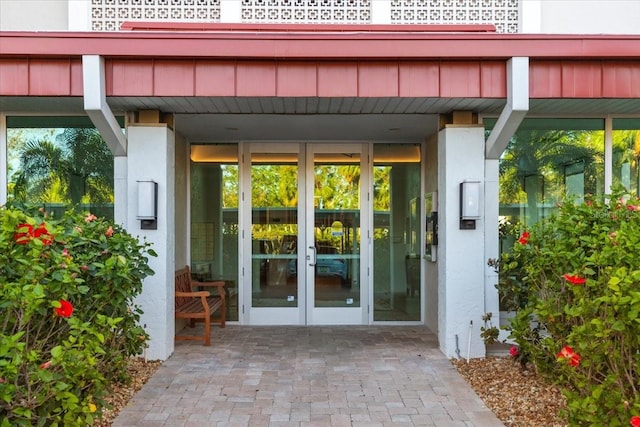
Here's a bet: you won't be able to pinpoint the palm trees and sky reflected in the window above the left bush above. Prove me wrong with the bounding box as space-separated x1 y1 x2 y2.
13 128 113 204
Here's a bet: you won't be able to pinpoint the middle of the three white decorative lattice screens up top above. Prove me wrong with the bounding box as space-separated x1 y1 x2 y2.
242 0 375 24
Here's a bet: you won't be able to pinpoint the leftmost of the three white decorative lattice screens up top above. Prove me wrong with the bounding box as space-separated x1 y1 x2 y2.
91 0 220 31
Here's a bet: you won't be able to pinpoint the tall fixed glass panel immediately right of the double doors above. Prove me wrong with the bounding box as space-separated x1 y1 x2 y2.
373 144 424 321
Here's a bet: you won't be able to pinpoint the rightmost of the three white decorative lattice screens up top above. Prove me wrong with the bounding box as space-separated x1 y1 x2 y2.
391 0 520 33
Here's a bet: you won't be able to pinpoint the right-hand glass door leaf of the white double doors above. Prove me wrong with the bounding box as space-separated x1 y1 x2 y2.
307 144 366 324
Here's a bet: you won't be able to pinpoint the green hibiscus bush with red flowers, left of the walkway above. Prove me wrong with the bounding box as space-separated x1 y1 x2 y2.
0 207 155 427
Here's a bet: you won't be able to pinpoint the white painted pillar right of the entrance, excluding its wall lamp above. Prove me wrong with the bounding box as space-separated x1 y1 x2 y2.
438 125 487 358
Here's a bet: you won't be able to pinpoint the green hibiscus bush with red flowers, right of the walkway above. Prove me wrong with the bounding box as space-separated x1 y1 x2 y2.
499 191 640 426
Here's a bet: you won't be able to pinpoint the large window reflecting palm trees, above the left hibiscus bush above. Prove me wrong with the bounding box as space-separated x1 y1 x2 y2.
7 116 114 220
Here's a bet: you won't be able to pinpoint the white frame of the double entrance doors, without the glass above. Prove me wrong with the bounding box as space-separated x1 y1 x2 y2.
238 141 372 325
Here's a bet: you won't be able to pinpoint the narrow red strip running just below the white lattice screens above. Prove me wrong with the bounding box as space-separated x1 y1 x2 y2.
120 21 496 33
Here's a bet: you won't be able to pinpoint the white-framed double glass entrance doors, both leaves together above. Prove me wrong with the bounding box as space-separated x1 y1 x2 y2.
240 143 369 325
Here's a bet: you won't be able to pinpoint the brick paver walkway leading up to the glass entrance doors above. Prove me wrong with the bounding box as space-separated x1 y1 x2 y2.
113 325 503 427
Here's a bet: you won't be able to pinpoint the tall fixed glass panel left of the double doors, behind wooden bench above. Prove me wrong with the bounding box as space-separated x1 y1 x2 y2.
191 144 239 320
